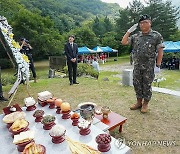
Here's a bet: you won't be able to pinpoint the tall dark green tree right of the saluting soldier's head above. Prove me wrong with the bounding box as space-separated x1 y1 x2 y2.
142 0 179 40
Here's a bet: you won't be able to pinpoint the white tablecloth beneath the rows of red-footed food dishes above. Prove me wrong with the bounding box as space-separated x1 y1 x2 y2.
0 105 130 154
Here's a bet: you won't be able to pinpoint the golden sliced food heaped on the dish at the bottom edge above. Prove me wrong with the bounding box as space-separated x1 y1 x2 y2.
22 142 46 154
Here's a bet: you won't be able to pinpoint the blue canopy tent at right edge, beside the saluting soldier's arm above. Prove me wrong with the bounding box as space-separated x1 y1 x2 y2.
163 41 180 52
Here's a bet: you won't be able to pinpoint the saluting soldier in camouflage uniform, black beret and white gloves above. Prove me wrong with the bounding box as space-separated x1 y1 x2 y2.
121 15 164 113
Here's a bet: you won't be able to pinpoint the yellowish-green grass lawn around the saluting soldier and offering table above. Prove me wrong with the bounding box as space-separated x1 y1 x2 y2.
0 58 180 154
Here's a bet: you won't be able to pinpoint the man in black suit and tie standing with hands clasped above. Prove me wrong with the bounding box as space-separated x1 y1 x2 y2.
64 35 79 85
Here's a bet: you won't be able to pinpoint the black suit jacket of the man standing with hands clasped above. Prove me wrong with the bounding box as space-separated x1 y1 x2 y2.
64 42 78 61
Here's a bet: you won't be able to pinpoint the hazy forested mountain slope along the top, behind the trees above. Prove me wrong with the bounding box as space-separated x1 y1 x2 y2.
20 0 120 32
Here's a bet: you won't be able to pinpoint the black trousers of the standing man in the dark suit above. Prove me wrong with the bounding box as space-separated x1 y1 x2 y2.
67 61 77 83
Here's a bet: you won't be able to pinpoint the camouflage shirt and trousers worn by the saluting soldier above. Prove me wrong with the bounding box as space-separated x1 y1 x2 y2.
128 30 163 102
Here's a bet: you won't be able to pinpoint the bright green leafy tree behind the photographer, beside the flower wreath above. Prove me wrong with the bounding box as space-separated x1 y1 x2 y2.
12 8 64 58
